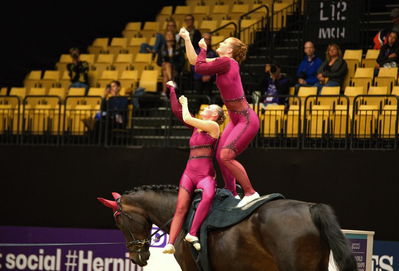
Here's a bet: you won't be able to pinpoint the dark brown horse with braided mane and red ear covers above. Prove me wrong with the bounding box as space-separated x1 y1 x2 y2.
98 185 357 271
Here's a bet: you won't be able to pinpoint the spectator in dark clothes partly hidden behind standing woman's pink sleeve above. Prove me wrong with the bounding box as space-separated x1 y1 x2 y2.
192 33 217 98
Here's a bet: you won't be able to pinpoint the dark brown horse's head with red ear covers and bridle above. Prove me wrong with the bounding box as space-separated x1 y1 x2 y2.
97 193 152 266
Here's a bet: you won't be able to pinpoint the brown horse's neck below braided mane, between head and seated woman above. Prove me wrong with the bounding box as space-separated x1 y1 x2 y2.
129 191 177 232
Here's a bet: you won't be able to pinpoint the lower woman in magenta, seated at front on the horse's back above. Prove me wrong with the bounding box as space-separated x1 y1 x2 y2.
163 81 224 253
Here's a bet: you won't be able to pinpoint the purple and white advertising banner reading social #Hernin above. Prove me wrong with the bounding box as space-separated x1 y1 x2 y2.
0 226 180 271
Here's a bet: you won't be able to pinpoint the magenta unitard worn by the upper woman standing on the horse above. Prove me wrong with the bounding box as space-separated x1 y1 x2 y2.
195 49 259 196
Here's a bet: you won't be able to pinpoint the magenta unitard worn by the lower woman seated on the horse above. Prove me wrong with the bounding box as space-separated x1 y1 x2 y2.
168 86 217 244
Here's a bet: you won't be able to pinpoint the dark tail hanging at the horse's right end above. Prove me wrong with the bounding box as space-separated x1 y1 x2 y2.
310 204 357 271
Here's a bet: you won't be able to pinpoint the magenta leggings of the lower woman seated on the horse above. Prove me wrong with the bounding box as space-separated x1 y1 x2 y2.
169 172 216 244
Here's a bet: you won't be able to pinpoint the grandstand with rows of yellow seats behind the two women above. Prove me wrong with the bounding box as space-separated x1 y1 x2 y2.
0 0 399 149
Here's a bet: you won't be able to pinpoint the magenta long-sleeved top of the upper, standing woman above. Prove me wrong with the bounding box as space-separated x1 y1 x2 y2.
195 49 244 101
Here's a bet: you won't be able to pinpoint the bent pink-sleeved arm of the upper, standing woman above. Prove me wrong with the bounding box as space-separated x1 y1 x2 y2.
195 48 231 75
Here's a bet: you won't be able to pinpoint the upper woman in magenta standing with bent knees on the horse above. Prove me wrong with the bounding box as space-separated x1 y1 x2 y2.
179 28 259 207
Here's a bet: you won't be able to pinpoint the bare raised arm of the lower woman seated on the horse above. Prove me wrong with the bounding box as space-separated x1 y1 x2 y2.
179 96 220 138
